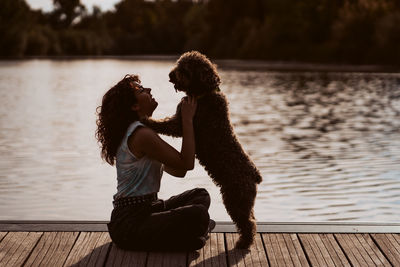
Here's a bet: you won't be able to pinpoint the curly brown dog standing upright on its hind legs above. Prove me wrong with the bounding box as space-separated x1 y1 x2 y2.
144 51 262 249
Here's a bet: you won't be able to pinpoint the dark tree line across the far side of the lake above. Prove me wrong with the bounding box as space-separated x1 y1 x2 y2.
0 0 400 65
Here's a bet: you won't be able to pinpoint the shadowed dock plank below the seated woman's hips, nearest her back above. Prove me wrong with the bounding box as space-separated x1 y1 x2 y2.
105 244 148 267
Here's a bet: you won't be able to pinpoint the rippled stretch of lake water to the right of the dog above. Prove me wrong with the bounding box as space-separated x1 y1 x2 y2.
223 69 400 221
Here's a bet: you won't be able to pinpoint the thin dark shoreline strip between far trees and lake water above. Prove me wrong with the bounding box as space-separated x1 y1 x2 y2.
0 54 400 73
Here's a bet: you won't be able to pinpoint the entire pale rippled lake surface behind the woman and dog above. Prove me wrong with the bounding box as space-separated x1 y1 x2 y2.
0 59 400 222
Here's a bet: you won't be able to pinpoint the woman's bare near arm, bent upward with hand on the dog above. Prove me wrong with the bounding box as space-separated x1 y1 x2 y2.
128 98 197 171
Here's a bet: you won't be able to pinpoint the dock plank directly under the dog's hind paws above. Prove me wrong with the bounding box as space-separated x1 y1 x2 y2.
225 233 269 267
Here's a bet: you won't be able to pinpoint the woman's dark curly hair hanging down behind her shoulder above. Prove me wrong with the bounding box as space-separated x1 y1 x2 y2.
96 74 140 165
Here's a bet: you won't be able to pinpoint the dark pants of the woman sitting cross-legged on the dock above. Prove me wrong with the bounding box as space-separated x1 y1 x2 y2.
108 188 210 251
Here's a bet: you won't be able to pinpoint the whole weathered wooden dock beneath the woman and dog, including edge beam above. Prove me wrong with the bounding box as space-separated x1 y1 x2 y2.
0 221 400 267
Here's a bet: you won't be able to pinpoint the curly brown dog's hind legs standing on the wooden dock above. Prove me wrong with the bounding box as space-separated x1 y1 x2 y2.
221 183 257 249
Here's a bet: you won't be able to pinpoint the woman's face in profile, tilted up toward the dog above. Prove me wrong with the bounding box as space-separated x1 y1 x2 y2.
132 83 158 117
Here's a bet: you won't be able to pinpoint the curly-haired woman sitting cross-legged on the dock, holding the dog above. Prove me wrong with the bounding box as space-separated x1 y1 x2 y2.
96 75 215 250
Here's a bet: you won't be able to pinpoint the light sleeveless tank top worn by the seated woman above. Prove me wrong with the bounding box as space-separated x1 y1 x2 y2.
114 121 163 200
